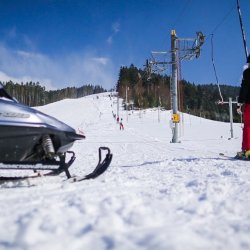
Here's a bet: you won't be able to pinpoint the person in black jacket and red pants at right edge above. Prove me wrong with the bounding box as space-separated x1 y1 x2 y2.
236 55 250 159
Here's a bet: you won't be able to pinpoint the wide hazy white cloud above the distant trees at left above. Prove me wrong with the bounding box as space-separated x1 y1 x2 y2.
0 44 116 89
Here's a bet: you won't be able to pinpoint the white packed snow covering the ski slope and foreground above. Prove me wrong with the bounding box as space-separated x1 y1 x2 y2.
0 93 250 250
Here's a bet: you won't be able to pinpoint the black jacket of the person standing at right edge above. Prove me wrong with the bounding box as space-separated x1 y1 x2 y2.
238 67 250 103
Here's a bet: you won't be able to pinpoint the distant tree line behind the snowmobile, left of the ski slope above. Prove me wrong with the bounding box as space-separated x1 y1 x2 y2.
1 81 106 107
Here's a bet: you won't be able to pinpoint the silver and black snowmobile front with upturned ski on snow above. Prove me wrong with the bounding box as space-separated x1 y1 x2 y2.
0 83 112 181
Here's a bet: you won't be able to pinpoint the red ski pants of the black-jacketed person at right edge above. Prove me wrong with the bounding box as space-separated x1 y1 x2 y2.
242 104 250 150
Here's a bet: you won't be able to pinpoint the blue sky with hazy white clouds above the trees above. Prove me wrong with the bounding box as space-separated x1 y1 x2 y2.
0 0 250 89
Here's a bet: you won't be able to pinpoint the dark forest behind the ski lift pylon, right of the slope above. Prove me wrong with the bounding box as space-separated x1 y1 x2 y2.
116 64 240 122
